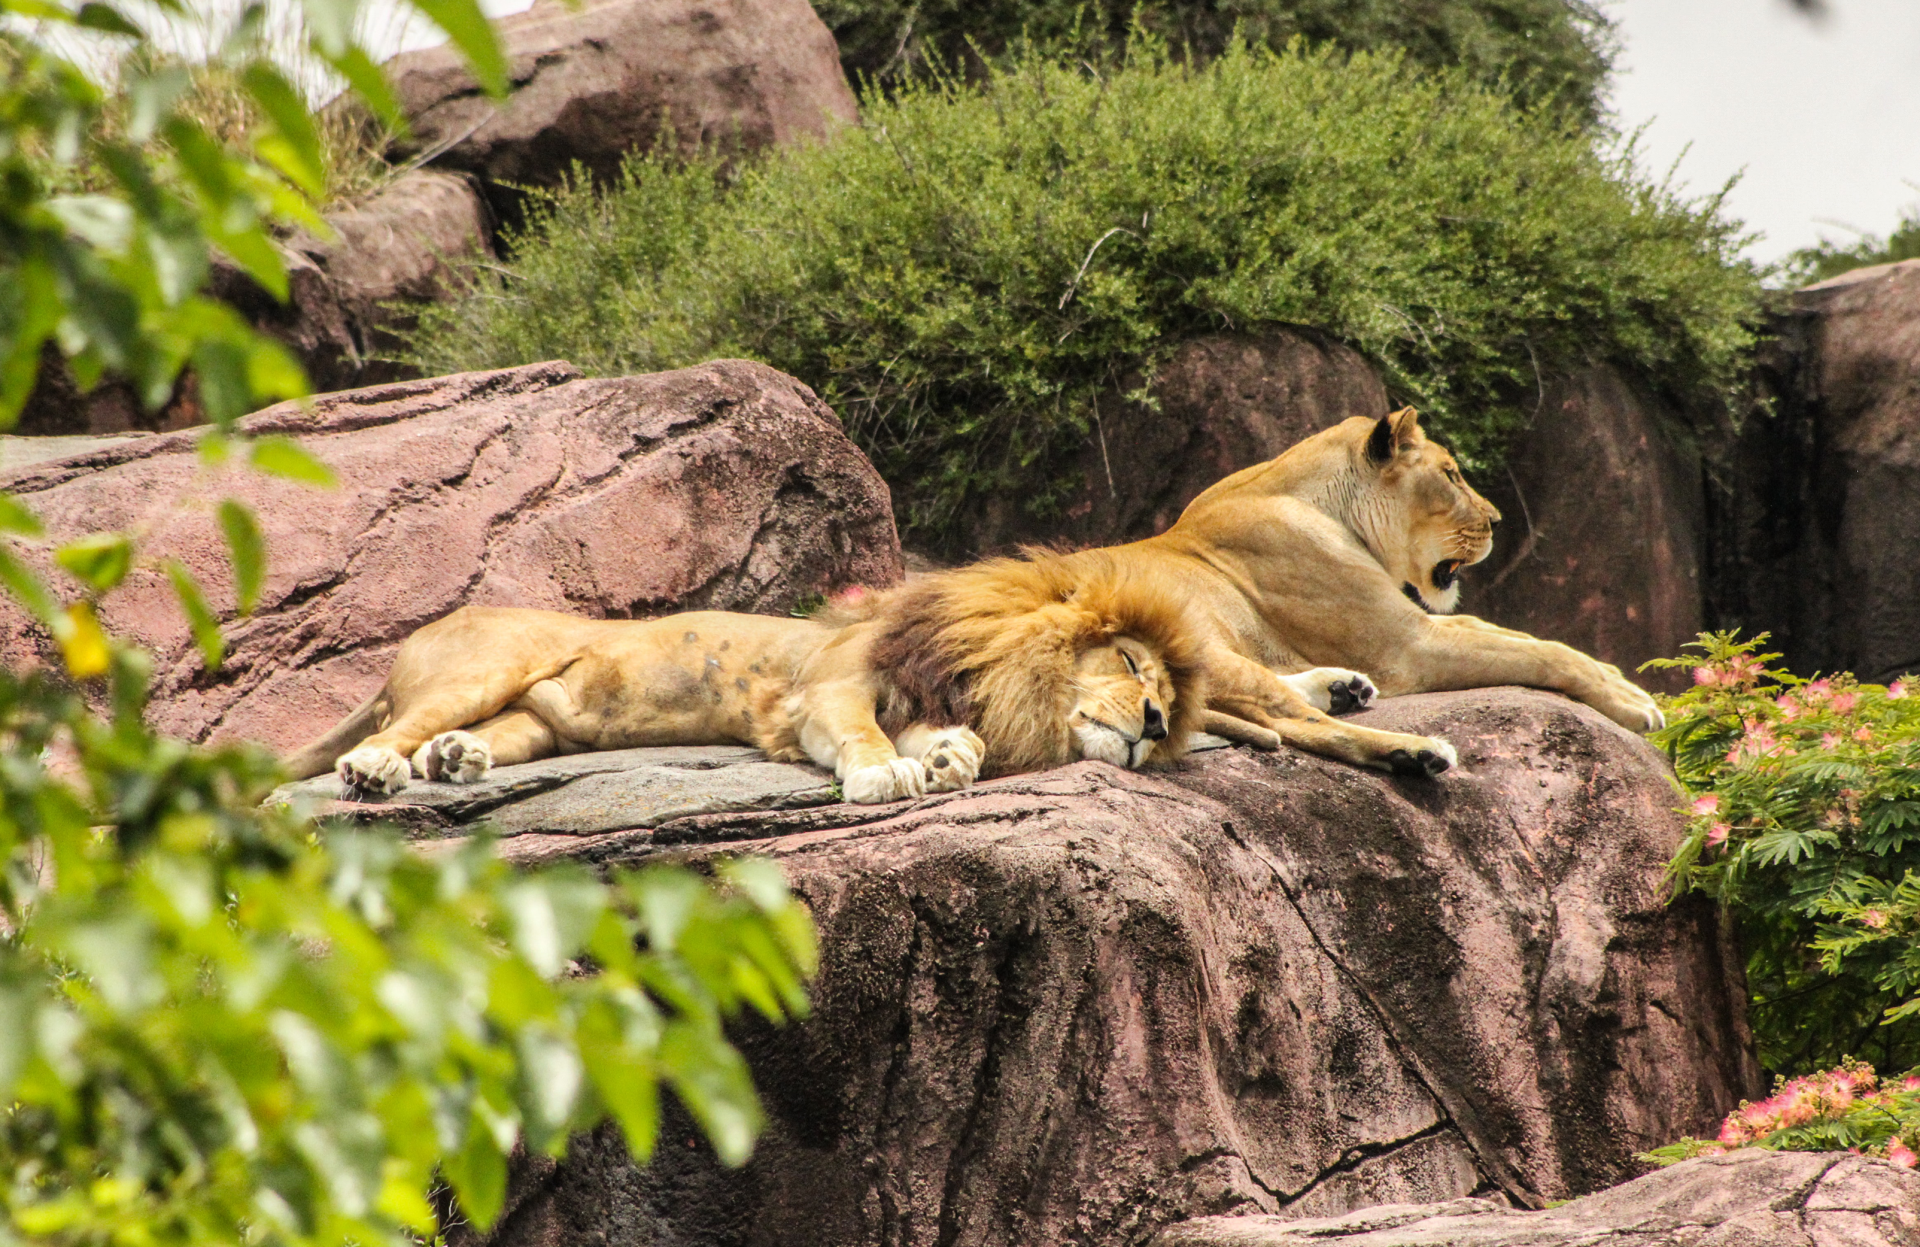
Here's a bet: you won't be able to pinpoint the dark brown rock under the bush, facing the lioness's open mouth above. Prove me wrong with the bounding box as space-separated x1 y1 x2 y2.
1461 367 1707 692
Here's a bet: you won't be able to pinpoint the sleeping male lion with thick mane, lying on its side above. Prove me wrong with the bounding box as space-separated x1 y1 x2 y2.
288 553 1373 803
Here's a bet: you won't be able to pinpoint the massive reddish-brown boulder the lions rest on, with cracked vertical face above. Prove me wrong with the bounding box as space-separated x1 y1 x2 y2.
445 690 1757 1247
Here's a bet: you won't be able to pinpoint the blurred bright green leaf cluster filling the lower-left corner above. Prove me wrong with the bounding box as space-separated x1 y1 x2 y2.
0 649 814 1247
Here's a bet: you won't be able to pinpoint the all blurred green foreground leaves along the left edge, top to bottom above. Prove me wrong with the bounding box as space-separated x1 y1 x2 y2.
0 9 814 1247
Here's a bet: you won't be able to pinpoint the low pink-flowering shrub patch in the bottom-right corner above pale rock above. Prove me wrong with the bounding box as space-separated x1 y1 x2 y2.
1640 1061 1920 1168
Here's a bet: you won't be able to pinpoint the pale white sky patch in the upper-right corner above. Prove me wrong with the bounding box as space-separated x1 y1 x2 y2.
1605 0 1920 261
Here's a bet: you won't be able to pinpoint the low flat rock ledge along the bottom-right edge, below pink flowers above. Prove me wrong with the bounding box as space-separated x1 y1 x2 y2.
1152 1147 1920 1247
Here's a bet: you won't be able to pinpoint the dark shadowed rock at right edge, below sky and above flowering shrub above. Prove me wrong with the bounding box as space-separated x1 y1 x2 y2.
1711 259 1920 680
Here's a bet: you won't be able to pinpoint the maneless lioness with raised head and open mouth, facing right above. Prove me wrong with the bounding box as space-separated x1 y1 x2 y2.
1044 407 1665 774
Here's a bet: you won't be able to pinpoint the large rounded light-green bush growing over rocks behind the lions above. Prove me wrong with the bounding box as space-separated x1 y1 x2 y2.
413 48 1757 542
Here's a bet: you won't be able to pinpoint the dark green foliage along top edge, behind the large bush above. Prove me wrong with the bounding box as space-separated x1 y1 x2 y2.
814 0 1613 119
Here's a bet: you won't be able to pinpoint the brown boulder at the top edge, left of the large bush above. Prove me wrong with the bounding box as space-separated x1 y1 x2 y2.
386 0 858 184
